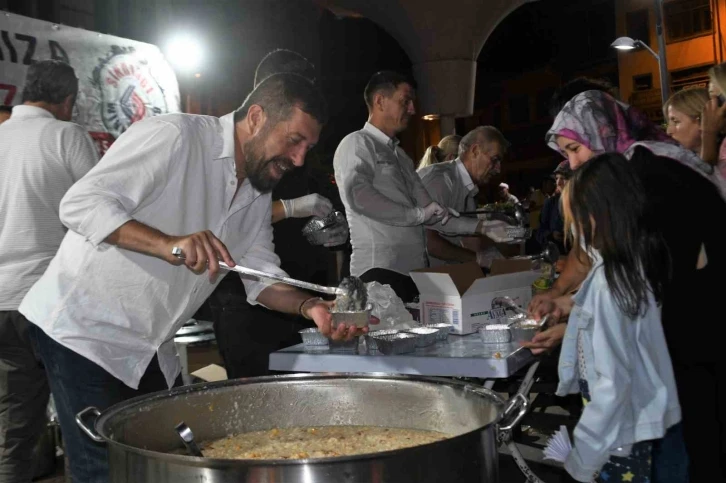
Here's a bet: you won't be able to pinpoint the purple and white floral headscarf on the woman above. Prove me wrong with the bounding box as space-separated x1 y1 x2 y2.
545 91 726 199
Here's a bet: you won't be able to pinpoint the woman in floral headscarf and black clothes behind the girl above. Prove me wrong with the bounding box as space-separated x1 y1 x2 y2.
530 91 726 481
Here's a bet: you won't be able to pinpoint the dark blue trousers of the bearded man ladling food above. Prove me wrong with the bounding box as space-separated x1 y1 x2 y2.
30 324 181 483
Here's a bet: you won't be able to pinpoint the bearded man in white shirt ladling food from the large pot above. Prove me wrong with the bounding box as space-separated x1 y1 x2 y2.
20 74 354 483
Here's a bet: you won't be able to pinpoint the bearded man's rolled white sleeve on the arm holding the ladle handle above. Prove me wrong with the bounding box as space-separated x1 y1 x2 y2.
60 119 185 246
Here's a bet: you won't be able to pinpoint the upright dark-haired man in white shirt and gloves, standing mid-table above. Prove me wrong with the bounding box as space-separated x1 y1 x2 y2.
333 71 520 301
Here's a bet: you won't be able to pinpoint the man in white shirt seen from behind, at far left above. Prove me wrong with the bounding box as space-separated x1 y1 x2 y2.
0 60 98 483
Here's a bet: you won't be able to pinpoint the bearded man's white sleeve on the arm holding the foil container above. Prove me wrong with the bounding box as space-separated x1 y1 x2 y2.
235 197 288 305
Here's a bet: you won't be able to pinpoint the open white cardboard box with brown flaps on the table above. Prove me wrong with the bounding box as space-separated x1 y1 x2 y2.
411 260 542 334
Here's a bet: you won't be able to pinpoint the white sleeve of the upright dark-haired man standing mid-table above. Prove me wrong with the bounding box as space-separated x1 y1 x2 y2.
333 136 425 226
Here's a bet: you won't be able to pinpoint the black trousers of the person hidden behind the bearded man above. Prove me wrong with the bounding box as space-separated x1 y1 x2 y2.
209 277 315 379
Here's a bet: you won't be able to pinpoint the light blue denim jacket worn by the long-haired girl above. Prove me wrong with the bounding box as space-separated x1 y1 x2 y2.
557 251 681 481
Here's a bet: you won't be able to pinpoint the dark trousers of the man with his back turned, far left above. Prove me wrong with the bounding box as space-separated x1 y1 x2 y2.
0 310 49 483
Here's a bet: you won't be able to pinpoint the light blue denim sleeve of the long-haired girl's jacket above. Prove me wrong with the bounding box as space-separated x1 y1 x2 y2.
565 287 635 481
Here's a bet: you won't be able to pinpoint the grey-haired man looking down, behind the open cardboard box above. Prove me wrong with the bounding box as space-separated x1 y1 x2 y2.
418 126 509 268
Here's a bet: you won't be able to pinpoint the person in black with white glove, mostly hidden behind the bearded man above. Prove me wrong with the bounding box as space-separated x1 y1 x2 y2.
209 49 348 379
